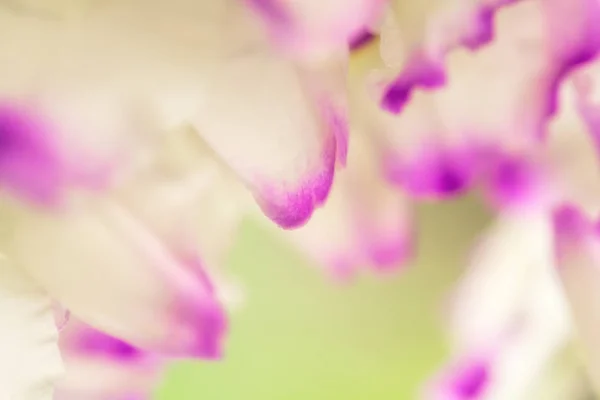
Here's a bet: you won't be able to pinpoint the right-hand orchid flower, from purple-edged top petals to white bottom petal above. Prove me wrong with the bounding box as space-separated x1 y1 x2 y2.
352 0 600 400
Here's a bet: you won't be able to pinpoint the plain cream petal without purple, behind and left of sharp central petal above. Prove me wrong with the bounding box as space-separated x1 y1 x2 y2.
117 127 247 268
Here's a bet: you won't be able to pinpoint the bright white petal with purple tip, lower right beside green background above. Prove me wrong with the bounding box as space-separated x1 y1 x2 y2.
424 214 573 400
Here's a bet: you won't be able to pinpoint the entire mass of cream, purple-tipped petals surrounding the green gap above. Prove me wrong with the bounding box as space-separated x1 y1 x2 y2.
5 0 600 400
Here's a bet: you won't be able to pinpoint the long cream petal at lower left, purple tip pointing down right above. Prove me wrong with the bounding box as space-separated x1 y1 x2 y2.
4 195 227 358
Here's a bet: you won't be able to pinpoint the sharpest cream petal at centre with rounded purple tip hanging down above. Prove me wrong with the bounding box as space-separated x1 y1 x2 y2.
195 54 337 228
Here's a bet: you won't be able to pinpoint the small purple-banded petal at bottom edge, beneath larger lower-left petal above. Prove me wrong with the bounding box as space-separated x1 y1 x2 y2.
56 321 163 400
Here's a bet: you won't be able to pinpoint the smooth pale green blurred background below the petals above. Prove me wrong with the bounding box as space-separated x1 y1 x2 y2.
157 198 487 400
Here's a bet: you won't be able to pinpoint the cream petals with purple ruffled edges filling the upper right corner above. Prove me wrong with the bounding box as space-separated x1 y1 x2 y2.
373 0 600 208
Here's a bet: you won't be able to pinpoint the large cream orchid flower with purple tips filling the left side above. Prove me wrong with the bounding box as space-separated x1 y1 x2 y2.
0 0 386 400
